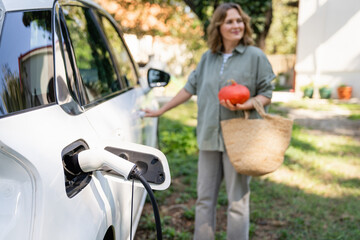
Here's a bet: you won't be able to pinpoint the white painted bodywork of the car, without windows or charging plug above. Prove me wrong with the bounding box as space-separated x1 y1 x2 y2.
0 0 170 240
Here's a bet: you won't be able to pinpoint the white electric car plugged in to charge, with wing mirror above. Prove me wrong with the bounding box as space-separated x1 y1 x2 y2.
0 0 170 240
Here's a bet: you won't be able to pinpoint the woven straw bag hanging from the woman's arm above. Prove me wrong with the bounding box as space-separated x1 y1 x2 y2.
221 98 293 176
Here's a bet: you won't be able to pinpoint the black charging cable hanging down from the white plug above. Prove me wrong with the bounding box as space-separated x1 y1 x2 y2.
129 168 162 240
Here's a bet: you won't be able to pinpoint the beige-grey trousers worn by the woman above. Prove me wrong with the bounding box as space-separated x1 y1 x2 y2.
194 151 251 240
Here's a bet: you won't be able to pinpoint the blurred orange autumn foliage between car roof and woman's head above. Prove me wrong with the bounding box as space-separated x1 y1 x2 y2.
96 0 206 72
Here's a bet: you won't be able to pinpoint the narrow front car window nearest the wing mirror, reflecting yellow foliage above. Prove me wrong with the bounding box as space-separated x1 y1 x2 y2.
99 14 137 88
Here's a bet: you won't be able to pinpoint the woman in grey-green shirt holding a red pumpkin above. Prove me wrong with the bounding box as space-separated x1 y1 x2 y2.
145 3 275 240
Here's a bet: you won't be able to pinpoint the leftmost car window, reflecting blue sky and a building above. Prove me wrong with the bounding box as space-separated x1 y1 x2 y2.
0 10 55 117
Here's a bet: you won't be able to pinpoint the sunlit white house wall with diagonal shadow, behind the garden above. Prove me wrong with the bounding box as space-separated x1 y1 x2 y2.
295 0 360 98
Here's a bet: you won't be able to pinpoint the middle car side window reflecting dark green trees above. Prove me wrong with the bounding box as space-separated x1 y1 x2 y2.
63 6 121 103
